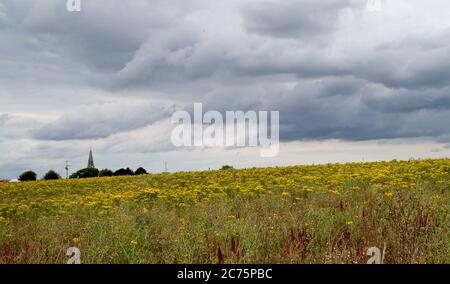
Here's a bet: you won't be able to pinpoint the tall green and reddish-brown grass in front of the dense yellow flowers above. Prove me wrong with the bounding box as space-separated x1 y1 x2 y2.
0 183 450 264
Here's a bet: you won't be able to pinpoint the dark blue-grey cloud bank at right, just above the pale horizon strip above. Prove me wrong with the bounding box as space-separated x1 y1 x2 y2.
270 79 450 140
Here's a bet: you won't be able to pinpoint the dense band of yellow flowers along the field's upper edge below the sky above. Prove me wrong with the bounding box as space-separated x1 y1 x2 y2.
0 159 450 217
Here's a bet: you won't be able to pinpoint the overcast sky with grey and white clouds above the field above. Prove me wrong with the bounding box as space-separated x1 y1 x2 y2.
0 0 450 179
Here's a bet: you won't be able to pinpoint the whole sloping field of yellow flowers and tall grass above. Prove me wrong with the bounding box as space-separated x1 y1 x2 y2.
0 159 450 263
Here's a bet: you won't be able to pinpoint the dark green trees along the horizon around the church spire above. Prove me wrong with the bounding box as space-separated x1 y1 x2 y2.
19 167 148 181
